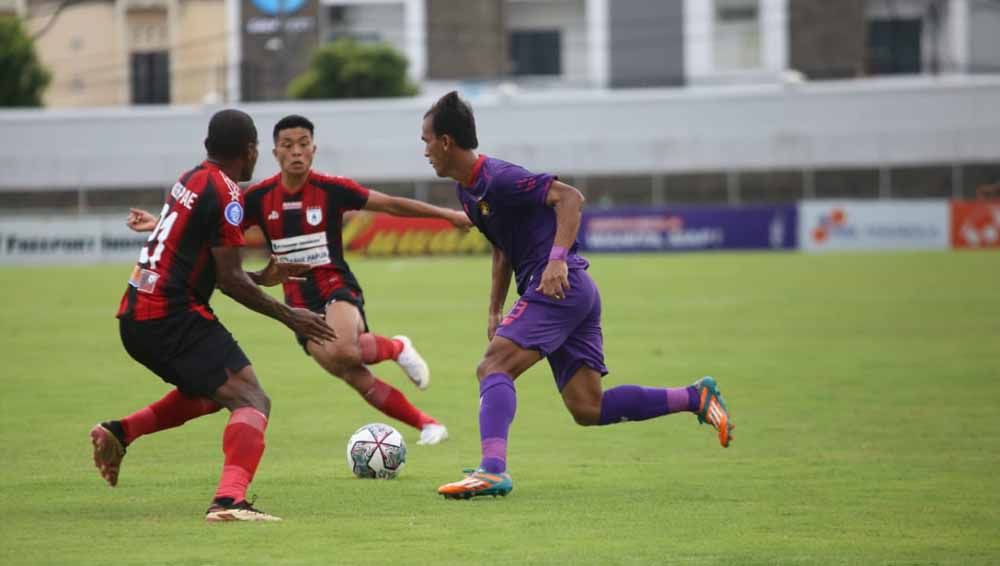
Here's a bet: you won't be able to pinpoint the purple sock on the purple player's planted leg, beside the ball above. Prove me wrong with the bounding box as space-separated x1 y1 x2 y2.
479 373 517 474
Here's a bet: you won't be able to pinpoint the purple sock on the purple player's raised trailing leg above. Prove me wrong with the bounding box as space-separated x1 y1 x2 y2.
598 385 698 425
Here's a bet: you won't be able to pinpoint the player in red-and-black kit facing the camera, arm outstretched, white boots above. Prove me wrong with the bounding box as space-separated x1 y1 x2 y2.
243 115 471 444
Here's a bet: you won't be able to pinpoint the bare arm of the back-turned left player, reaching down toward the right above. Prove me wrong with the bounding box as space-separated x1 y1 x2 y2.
212 246 337 344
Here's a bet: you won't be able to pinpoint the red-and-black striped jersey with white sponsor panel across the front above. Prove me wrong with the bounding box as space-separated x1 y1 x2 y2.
243 171 369 311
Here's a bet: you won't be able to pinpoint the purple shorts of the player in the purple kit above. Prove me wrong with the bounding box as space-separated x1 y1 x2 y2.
497 269 608 391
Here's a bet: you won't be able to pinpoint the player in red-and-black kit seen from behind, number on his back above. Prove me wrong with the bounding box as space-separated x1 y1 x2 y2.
90 110 336 521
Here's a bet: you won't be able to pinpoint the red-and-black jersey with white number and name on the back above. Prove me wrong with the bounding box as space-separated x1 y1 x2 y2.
118 161 244 320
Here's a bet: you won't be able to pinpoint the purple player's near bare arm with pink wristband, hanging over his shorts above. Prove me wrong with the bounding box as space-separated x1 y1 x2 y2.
536 181 584 299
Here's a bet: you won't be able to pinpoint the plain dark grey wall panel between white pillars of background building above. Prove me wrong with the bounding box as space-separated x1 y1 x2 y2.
609 0 684 87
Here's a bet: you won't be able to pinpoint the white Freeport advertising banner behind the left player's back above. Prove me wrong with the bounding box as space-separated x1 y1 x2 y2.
0 214 149 265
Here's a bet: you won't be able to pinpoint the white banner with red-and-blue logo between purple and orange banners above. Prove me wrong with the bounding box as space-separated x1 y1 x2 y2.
799 200 950 252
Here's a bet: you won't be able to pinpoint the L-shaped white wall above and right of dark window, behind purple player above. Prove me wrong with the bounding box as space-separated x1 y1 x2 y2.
507 0 589 83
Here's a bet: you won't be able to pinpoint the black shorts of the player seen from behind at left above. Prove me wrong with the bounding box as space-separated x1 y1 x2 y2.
118 312 250 397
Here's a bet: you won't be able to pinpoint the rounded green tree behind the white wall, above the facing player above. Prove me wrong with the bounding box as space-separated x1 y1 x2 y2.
288 38 417 99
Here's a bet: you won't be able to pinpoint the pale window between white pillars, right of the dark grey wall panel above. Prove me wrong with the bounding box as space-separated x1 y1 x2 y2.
713 0 762 71
